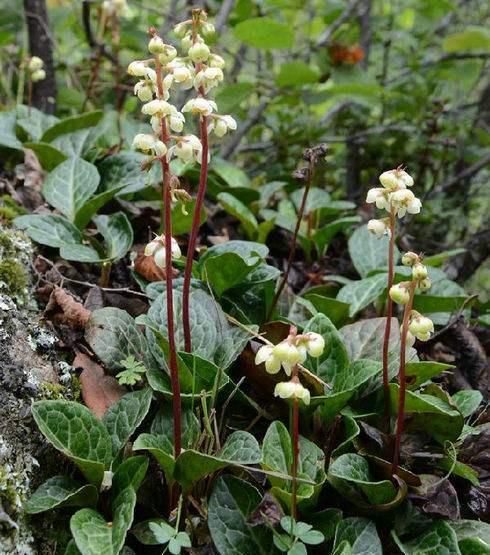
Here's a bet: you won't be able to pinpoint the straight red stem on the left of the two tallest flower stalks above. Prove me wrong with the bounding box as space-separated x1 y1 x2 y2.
150 33 182 458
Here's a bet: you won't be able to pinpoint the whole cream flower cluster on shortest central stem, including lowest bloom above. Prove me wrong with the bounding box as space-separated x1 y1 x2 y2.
255 328 325 404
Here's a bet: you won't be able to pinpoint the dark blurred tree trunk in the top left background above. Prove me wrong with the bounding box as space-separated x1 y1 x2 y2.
24 0 56 114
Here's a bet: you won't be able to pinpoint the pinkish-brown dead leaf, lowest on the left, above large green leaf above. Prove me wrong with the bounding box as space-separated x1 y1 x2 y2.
73 353 126 419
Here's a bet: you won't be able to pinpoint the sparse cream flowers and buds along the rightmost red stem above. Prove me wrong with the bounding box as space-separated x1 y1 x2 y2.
389 252 434 345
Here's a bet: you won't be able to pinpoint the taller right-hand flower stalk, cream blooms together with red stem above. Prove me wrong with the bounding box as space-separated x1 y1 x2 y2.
366 166 422 418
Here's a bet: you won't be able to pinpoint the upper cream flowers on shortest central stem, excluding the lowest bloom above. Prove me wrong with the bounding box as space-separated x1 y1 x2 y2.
255 332 325 376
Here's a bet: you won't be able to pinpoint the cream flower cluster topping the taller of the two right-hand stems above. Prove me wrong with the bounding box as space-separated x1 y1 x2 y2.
366 167 422 233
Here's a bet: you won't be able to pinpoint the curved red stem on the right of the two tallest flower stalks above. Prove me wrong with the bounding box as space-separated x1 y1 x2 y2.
182 9 209 353
